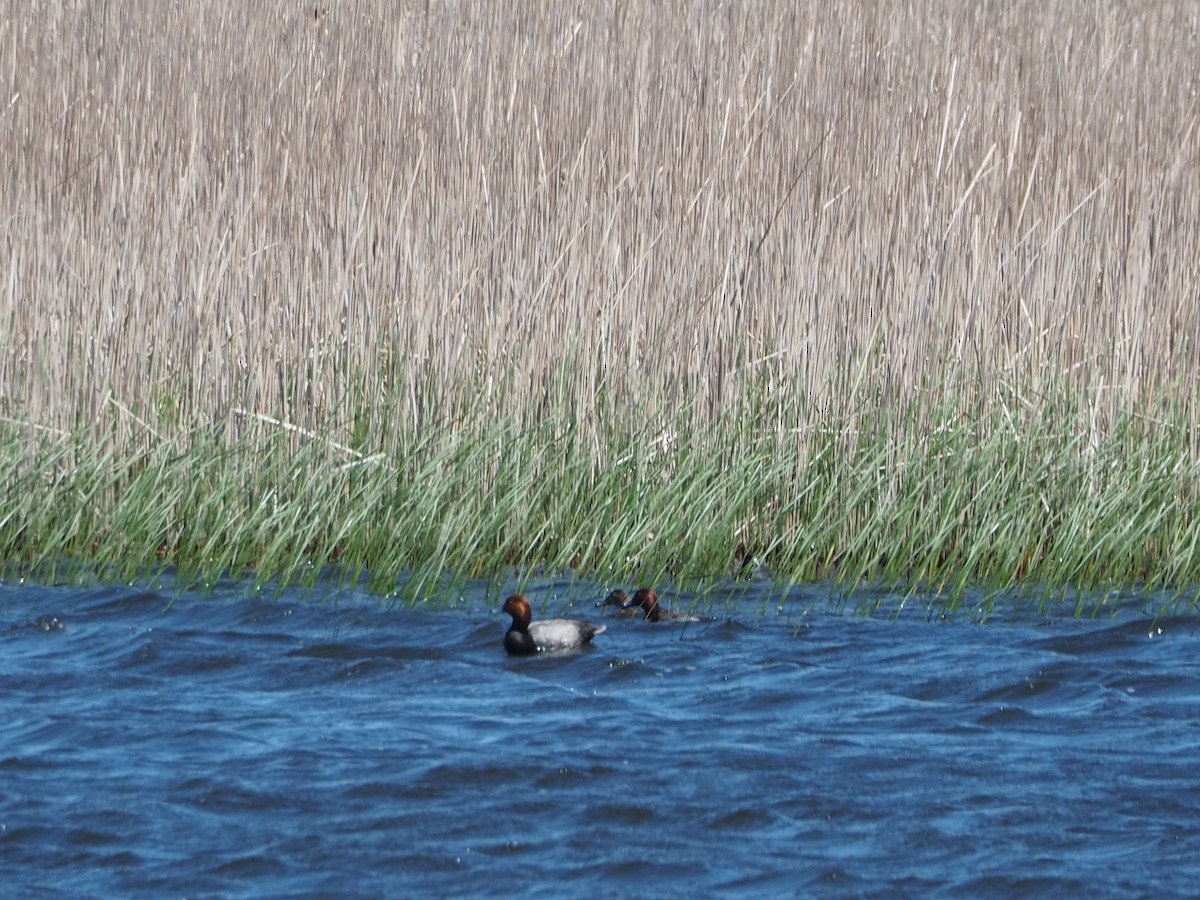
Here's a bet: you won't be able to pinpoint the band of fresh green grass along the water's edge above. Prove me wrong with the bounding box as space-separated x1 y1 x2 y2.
0 367 1200 612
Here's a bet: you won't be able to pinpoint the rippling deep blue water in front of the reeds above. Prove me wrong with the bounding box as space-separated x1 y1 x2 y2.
0 573 1200 898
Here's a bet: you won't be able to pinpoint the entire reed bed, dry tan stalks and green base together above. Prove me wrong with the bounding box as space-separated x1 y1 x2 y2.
0 0 1200 606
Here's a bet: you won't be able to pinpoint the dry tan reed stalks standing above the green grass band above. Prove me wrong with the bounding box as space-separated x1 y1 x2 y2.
0 0 1200 445
